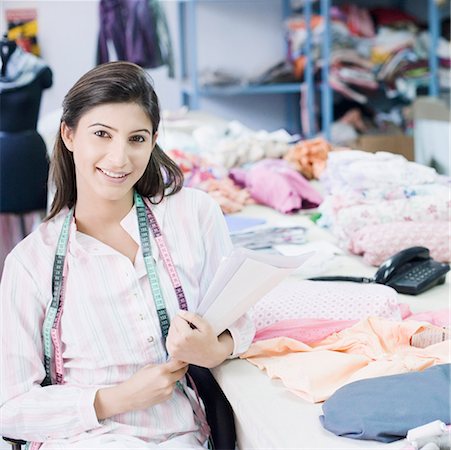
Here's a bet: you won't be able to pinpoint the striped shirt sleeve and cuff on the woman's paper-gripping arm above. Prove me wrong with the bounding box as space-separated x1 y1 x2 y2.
201 195 255 358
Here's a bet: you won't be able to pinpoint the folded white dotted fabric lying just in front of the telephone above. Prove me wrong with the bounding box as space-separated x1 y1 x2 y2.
250 280 401 331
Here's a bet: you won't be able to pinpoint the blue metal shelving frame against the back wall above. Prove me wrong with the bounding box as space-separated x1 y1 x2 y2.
178 0 439 138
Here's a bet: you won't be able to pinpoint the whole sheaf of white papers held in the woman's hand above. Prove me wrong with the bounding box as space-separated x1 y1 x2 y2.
196 248 313 336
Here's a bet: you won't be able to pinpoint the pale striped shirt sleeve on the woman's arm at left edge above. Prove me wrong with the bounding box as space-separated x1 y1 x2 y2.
0 254 100 442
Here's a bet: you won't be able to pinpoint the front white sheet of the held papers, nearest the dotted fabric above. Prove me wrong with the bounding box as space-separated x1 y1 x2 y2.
197 251 310 335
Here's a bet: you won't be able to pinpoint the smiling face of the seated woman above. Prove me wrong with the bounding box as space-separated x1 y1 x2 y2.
61 103 156 201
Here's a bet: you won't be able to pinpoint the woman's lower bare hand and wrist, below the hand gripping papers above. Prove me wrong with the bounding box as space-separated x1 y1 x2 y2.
94 359 188 420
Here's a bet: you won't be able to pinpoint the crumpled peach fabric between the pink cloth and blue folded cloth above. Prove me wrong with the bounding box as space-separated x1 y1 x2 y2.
241 317 450 403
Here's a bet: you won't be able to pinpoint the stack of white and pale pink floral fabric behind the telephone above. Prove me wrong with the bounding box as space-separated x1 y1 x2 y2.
317 150 451 265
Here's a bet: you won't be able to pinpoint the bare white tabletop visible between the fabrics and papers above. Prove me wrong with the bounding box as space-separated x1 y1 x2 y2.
213 205 450 450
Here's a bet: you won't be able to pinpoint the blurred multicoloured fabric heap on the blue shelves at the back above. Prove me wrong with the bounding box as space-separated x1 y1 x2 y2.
286 5 451 104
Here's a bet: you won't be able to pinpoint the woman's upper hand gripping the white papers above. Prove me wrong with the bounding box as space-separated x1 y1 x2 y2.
166 310 237 368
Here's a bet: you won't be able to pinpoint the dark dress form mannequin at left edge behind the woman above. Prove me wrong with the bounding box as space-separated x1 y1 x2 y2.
0 36 52 273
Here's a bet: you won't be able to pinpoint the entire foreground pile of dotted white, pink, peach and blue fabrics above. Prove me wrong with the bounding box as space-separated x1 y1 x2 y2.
247 280 451 442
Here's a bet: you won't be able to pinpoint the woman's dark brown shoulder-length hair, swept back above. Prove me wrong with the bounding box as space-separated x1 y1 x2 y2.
46 61 183 220
